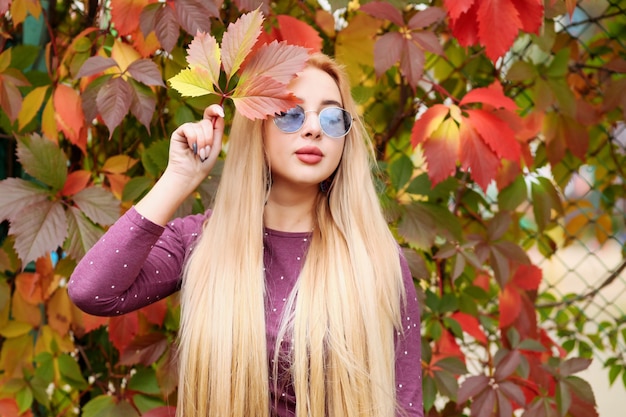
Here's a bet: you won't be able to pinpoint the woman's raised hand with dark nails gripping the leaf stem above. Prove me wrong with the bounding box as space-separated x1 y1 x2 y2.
166 104 224 186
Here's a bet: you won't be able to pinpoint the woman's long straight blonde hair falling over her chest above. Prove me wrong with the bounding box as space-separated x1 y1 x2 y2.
178 54 405 417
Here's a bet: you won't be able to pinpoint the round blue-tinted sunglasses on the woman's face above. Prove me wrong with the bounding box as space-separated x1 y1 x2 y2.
274 106 352 139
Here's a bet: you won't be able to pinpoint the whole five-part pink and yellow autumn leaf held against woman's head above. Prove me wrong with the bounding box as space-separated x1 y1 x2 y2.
169 9 308 119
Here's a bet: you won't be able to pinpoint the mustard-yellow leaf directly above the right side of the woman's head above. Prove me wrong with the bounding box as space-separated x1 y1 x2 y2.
335 14 382 85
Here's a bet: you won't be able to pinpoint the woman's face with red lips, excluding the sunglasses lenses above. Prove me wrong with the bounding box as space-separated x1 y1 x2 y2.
264 67 345 191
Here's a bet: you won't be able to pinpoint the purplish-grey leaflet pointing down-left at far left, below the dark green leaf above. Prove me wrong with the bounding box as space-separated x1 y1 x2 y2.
9 201 67 265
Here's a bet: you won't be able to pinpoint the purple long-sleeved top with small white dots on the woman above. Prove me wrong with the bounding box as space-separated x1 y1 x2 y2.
68 208 423 417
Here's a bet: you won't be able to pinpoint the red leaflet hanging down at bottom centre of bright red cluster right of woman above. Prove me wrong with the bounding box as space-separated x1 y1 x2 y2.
460 123 500 190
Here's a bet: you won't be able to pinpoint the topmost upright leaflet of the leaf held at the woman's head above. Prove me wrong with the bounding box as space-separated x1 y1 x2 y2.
222 9 263 80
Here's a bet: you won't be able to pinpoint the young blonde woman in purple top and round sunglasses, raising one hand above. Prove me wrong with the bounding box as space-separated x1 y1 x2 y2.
69 54 423 417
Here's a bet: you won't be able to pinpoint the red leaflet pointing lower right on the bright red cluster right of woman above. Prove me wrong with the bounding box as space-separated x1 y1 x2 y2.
463 109 522 161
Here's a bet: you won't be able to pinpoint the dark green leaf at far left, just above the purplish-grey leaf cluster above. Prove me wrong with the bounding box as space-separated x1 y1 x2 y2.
17 135 67 191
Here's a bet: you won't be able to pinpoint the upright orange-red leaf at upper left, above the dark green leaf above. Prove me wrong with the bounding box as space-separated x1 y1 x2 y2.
53 84 87 152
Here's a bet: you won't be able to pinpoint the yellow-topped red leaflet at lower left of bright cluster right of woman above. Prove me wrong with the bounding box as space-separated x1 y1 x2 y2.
422 119 460 186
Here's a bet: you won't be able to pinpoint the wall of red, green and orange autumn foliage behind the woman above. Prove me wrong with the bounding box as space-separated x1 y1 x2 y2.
0 0 626 417
